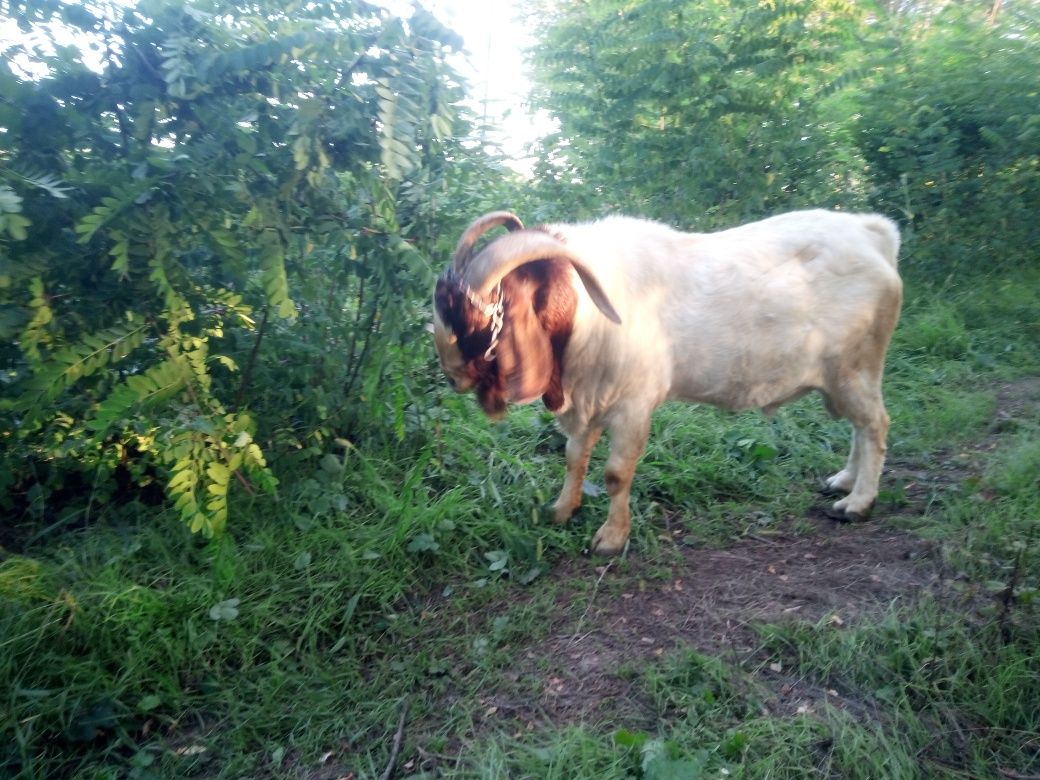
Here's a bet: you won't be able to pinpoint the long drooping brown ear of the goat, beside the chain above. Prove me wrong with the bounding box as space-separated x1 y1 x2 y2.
497 296 553 404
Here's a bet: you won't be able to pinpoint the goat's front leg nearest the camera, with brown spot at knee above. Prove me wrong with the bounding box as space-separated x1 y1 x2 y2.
589 410 650 555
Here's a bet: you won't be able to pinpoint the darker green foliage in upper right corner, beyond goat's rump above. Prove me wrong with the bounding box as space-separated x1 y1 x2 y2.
853 3 1040 274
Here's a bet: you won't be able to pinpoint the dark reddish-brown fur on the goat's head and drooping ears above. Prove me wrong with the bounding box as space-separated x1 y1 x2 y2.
434 260 577 417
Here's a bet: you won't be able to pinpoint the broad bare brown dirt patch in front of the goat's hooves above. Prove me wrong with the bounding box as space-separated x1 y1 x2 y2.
480 517 938 726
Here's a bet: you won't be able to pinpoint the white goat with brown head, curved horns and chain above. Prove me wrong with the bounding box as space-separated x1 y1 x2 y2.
434 210 903 555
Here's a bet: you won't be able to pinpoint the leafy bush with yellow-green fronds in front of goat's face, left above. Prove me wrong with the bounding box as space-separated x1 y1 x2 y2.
0 0 495 534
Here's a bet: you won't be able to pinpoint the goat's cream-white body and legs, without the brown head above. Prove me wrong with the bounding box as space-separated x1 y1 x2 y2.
435 210 902 553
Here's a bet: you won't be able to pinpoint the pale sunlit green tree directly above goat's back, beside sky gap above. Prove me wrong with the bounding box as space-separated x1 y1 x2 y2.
531 0 870 227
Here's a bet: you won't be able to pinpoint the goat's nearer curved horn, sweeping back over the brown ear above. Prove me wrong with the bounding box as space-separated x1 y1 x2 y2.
465 230 621 324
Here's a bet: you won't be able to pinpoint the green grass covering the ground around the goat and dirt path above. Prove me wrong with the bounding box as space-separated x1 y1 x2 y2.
0 271 1040 779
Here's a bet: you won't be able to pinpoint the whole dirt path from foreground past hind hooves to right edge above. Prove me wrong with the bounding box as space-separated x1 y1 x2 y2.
436 379 1040 744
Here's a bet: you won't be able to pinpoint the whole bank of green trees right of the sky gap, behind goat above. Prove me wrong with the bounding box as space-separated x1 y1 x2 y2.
530 0 1040 250
